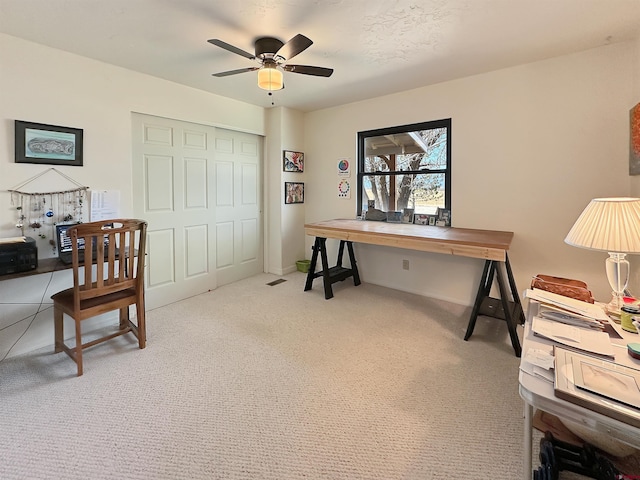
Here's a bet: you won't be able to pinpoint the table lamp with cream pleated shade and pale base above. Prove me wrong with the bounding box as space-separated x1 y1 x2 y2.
564 198 640 313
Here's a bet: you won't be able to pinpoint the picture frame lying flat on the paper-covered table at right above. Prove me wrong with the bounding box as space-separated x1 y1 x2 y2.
554 346 640 428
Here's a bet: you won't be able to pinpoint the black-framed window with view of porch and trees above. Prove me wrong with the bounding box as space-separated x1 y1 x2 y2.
357 118 451 219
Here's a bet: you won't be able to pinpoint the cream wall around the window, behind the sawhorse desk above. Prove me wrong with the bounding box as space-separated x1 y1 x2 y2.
305 42 640 304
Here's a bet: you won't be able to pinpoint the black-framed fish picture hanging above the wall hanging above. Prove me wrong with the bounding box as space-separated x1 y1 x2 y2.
14 120 83 167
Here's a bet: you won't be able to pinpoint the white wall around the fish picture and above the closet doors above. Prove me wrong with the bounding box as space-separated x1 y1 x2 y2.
0 34 265 253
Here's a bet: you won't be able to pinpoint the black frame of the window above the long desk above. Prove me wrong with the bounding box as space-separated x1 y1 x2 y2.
356 118 452 217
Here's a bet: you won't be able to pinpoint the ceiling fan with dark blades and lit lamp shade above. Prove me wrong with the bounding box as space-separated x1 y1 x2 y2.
208 34 333 91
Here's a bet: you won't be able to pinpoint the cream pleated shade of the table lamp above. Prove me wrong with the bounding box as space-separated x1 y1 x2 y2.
564 198 640 253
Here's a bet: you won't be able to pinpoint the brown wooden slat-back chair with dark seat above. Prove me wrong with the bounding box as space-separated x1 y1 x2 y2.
51 219 147 376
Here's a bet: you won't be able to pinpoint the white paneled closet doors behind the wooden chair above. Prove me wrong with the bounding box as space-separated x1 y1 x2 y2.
133 114 263 308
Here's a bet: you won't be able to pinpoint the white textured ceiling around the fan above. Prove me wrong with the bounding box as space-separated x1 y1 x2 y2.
0 0 640 111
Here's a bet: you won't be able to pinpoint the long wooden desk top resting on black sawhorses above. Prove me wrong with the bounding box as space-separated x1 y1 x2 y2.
304 219 513 262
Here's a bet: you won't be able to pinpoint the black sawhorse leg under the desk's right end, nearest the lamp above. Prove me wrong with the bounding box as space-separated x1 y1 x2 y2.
464 254 524 357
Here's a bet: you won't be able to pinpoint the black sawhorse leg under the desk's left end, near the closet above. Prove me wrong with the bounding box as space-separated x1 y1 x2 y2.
304 237 360 300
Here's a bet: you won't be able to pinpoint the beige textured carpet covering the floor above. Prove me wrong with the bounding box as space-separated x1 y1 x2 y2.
0 272 524 480
